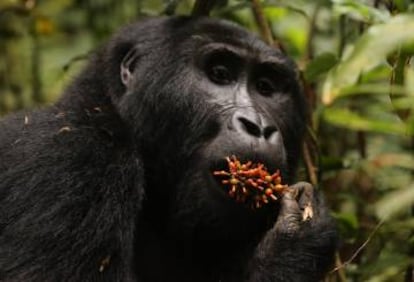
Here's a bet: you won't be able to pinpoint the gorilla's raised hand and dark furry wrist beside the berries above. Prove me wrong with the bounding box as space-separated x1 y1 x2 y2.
247 182 336 282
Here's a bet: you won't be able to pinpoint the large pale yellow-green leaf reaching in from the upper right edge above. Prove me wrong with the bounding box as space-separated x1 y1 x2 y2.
322 15 414 104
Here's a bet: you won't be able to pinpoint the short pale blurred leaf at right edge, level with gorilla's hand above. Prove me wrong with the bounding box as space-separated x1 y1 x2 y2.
375 183 414 219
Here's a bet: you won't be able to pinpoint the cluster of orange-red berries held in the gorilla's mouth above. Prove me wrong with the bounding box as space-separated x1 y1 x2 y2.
213 156 288 209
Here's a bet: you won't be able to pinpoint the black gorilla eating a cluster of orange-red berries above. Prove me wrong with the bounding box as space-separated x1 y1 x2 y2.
0 16 337 282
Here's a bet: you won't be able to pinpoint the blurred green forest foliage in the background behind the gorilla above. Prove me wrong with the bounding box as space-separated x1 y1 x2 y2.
0 0 414 282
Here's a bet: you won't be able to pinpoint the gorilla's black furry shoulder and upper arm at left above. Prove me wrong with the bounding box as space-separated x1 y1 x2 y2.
0 108 142 282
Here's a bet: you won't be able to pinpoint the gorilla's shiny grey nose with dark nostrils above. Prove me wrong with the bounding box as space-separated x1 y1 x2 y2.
232 113 278 144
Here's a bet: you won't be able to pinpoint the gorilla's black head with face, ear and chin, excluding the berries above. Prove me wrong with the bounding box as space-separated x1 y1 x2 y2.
115 18 305 246
